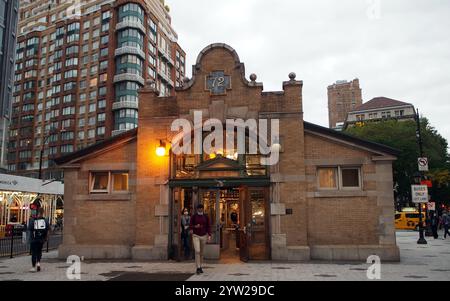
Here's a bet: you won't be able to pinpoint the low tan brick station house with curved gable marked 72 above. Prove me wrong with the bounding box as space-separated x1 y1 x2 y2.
57 44 400 261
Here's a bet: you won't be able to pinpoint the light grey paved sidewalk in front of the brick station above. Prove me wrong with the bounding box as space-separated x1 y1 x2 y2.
0 231 450 281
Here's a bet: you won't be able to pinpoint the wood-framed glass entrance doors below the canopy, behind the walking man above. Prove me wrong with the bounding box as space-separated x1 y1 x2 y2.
170 187 270 261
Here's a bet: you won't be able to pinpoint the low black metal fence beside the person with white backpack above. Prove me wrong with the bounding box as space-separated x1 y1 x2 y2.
0 231 63 258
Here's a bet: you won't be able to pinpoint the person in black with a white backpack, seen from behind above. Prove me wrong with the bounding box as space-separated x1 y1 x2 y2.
28 208 49 272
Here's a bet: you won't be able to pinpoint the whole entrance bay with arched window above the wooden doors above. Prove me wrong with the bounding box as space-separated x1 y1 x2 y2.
169 127 270 261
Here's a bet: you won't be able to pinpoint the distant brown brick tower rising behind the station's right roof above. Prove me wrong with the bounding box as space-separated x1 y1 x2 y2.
328 78 362 129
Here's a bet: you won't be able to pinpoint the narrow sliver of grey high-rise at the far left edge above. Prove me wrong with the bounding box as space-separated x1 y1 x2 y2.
0 0 19 169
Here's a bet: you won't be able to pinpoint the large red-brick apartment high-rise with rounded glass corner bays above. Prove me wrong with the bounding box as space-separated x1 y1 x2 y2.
8 0 185 178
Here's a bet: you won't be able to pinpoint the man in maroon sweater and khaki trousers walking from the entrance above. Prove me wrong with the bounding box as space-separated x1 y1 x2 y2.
190 204 211 275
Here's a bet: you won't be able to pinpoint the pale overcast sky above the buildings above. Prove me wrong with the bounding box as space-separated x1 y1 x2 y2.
170 0 450 141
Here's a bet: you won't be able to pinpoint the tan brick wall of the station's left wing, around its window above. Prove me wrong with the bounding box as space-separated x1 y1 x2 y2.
64 141 136 246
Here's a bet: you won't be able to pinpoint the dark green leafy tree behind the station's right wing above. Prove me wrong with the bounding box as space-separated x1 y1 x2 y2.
345 118 450 209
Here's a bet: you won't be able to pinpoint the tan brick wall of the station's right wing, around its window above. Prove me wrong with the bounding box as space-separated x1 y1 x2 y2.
305 134 386 245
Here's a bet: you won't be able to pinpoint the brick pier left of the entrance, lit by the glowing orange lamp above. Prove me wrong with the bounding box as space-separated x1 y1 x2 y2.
132 118 171 260
